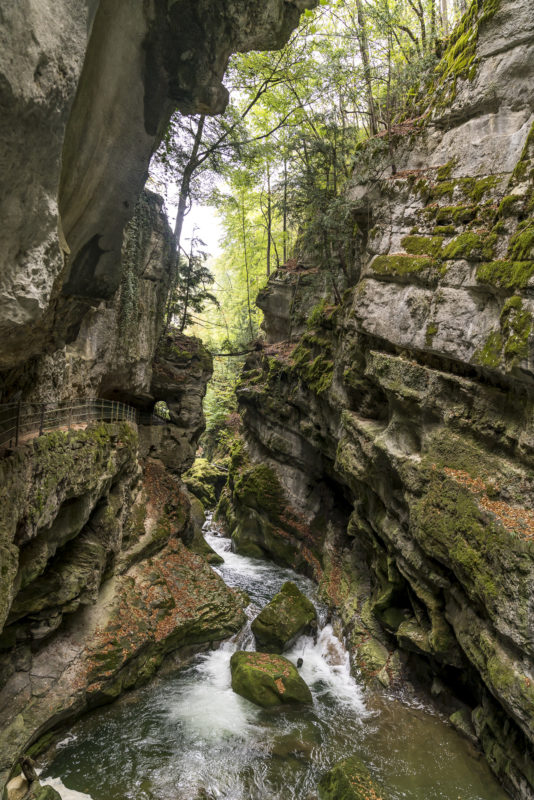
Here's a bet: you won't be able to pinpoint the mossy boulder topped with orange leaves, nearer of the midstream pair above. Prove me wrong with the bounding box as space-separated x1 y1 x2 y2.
230 650 312 708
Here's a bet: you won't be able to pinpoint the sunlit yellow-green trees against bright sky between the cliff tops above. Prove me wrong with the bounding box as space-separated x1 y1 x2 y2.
153 0 465 450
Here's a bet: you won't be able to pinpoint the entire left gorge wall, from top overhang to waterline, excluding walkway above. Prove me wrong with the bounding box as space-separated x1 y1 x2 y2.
0 0 316 792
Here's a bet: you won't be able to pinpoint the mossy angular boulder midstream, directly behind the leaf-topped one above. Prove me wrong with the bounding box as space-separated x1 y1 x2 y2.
251 581 317 653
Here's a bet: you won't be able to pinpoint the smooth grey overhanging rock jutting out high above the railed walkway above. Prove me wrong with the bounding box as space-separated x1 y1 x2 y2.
0 0 316 369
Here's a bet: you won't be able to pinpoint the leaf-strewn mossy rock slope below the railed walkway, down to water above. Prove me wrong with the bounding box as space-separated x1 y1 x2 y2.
0 423 244 786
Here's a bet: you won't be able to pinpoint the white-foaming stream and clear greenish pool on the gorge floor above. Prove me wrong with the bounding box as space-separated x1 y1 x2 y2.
42 515 507 800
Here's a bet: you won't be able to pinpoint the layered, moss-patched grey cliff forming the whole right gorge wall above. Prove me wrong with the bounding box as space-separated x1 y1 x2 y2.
224 0 534 799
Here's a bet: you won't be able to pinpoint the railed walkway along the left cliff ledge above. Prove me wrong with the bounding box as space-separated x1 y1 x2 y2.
0 399 167 455
